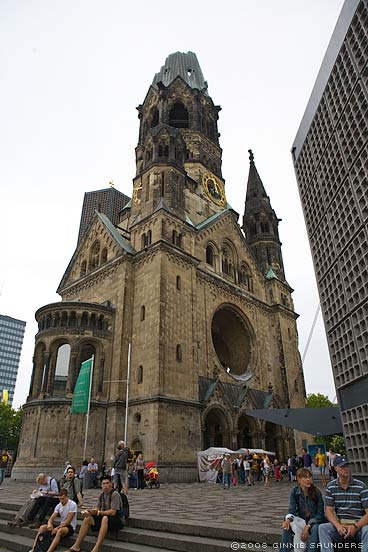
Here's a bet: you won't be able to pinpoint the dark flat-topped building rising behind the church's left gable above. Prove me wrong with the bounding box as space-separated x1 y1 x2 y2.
78 186 130 243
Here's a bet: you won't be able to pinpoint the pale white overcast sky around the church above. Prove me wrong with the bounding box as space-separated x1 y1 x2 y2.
0 0 343 407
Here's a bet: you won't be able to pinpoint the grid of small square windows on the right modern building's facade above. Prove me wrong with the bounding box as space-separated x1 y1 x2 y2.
295 2 368 474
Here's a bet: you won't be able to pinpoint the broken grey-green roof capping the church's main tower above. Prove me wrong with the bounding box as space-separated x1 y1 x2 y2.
152 52 207 95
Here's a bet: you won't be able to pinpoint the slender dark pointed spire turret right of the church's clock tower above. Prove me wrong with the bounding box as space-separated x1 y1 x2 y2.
242 150 285 281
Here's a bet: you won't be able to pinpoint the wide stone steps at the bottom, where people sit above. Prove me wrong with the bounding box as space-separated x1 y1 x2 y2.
0 497 279 552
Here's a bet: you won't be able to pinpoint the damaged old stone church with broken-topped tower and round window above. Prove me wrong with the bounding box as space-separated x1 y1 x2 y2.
14 52 305 481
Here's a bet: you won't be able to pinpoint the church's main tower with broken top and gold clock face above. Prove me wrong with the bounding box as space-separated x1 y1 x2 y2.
131 52 226 231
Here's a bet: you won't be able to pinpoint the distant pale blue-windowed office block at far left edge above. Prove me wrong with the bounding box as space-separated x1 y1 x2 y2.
0 314 26 405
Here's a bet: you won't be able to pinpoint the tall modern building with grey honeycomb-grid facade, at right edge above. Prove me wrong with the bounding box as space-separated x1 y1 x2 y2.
292 0 368 476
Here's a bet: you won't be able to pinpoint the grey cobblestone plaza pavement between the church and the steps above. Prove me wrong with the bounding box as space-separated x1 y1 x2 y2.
0 479 324 534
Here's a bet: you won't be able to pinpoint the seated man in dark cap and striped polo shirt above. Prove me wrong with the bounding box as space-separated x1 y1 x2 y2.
319 456 368 552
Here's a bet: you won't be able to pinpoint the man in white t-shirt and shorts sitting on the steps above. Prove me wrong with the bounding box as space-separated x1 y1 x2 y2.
30 489 77 552
